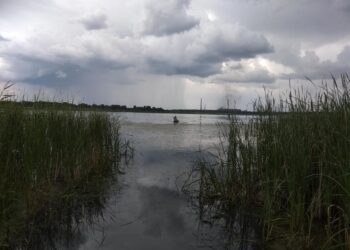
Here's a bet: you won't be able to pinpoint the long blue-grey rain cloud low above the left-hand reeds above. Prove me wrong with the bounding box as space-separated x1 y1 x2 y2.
3 46 130 87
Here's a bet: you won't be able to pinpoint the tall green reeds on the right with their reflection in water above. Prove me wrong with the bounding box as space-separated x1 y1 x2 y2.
183 75 350 249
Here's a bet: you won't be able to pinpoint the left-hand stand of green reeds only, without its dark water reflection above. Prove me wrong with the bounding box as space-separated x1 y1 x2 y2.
0 101 122 249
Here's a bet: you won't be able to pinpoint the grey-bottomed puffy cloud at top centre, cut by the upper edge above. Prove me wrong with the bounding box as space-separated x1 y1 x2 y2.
142 0 199 36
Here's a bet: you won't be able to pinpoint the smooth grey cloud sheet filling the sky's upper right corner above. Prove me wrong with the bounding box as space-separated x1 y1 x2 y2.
221 0 350 44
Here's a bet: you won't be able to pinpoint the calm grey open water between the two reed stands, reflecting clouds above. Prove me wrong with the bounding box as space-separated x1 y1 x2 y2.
74 113 238 250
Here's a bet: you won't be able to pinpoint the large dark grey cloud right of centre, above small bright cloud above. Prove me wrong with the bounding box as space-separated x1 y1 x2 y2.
146 23 273 77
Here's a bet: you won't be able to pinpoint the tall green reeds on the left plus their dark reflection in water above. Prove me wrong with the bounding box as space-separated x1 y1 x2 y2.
0 92 130 249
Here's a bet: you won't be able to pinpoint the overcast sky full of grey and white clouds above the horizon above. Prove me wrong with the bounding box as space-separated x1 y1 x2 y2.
0 0 350 109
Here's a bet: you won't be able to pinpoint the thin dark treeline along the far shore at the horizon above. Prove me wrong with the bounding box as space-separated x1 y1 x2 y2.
0 101 254 115
